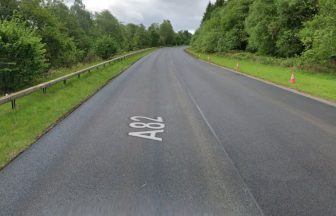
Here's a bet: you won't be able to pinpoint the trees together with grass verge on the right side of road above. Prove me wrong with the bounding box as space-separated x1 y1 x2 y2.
190 0 336 100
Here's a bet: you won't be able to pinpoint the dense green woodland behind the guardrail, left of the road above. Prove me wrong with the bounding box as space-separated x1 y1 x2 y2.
0 0 191 93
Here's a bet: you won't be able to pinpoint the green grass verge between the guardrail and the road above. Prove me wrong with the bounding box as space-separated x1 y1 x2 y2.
0 50 153 168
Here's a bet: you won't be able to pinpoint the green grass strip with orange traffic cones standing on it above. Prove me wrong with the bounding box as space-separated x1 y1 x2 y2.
188 49 336 101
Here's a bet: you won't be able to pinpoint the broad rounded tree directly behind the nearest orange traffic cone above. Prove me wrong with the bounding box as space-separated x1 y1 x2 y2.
246 0 317 57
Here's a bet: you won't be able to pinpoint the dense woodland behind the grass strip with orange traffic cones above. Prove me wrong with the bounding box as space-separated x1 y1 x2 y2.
191 0 336 65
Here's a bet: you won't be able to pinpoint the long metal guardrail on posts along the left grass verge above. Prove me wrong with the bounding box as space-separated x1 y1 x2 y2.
0 48 151 109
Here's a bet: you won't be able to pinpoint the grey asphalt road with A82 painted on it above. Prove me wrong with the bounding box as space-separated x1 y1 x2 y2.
0 48 336 216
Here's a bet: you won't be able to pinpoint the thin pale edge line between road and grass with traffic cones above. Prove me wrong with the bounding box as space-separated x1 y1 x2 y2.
186 51 336 107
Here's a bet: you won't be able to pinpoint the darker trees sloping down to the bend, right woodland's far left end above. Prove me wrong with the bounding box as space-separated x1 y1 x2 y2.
192 0 252 52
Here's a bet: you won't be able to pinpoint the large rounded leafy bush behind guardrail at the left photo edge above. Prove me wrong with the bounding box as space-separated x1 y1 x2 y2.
0 19 47 92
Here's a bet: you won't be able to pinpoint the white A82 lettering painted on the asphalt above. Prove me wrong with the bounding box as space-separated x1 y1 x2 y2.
128 116 165 142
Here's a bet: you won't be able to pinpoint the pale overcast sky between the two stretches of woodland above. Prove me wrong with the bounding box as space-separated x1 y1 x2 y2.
83 0 213 32
